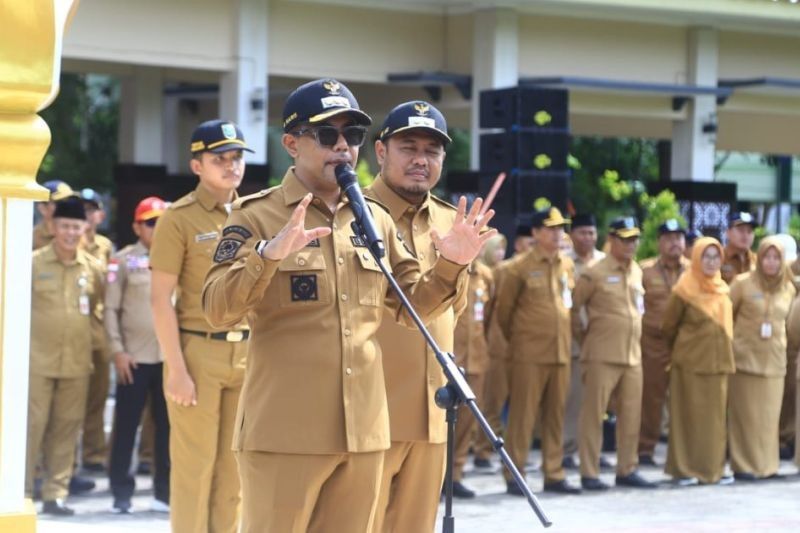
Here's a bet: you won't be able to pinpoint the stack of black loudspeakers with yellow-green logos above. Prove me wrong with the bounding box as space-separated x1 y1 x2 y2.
479 87 570 235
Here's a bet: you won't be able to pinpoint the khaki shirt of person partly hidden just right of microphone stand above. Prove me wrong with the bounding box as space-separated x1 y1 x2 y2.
453 261 494 374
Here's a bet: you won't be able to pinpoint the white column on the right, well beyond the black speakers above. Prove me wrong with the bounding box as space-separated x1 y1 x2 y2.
671 28 718 181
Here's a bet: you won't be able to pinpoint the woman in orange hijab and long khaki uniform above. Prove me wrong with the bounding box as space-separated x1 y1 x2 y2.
662 237 734 485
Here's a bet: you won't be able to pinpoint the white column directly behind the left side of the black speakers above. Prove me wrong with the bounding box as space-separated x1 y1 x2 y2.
470 9 519 169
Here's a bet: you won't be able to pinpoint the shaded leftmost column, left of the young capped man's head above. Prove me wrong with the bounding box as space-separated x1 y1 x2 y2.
119 67 164 165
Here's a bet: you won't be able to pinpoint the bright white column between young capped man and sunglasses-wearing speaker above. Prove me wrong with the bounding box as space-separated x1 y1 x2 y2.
219 0 269 164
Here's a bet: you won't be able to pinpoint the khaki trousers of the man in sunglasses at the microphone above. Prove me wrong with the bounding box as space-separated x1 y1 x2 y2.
238 451 384 533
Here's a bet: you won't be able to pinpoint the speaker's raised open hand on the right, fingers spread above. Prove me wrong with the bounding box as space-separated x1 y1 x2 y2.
431 196 497 265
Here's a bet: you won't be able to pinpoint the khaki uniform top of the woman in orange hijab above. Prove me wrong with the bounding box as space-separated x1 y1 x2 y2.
661 292 735 374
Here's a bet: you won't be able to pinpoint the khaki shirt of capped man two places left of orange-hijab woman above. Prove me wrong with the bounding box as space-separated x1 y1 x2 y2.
572 255 644 366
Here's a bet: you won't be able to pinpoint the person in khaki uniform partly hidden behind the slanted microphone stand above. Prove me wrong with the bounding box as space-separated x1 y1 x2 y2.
453 261 495 498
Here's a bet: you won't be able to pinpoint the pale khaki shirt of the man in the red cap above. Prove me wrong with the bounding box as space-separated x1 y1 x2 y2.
105 241 164 364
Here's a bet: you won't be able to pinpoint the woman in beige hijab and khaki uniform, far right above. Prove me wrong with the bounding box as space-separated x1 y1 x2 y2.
728 237 795 481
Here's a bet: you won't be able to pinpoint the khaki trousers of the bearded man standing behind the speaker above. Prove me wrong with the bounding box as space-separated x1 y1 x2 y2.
372 441 447 533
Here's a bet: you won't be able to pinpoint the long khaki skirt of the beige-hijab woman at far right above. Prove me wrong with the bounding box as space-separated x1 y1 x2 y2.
728 372 784 477
